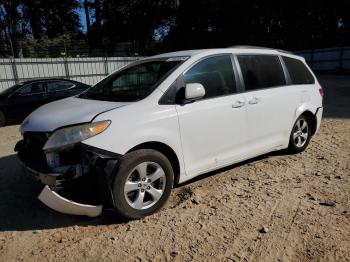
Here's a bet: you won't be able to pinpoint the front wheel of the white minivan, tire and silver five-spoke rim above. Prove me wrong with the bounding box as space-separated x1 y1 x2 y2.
112 149 174 219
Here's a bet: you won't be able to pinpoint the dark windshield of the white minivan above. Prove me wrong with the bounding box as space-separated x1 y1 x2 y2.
79 57 186 102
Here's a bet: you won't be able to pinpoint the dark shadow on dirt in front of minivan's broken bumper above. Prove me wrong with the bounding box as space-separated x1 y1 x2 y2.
0 155 126 232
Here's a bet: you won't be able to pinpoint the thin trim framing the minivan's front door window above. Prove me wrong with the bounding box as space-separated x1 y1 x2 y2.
158 52 244 105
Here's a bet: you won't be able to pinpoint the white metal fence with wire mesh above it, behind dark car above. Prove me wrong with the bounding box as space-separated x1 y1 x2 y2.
0 36 139 91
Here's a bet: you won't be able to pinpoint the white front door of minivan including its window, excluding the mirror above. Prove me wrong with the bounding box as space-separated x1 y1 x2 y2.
176 54 246 177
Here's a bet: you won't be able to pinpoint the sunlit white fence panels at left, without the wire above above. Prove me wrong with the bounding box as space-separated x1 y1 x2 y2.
0 57 139 91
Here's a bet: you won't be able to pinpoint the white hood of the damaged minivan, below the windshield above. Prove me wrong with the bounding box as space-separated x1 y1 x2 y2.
21 97 129 134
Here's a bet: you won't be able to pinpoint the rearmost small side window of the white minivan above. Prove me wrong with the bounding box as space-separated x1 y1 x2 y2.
282 56 315 85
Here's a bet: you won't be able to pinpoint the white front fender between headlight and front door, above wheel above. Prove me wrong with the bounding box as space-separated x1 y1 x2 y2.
83 100 185 178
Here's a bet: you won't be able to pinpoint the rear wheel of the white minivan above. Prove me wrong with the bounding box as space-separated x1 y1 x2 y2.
288 115 311 154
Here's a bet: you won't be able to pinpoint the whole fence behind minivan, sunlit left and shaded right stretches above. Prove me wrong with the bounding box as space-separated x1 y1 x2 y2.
0 47 350 91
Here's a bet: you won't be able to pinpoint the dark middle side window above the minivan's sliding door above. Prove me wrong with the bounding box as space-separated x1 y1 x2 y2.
237 55 286 91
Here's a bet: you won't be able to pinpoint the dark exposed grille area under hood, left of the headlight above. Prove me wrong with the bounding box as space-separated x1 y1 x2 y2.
18 132 48 171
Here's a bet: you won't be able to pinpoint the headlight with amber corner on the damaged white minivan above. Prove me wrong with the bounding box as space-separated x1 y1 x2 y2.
43 120 111 152
